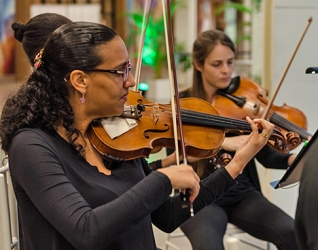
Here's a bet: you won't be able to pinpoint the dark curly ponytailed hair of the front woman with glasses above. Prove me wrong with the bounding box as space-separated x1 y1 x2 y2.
0 22 117 156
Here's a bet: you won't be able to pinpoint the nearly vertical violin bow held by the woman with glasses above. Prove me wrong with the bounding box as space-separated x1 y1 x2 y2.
162 0 194 216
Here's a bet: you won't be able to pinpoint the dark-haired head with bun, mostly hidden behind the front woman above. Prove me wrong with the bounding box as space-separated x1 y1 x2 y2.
11 13 72 65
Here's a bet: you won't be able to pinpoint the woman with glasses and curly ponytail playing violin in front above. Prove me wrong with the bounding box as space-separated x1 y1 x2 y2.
0 22 273 250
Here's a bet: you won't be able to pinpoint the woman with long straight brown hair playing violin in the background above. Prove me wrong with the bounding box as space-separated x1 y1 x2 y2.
157 30 298 250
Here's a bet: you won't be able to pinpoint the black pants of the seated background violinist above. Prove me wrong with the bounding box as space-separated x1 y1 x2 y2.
181 191 299 250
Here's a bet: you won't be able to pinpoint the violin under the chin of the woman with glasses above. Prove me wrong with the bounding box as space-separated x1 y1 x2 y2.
88 91 289 161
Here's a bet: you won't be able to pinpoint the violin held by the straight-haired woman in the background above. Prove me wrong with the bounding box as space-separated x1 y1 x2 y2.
212 76 312 166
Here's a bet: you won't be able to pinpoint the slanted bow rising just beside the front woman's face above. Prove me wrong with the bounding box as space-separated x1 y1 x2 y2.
134 0 152 91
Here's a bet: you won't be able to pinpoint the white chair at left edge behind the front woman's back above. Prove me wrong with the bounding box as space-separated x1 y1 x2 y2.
0 164 19 250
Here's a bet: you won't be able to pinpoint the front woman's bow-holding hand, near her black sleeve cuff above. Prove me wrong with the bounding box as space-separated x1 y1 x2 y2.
157 164 200 202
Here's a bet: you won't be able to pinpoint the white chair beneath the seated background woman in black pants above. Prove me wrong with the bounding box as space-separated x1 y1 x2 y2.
164 223 271 250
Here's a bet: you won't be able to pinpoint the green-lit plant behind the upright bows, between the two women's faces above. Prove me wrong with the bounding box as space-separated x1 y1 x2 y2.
127 0 185 78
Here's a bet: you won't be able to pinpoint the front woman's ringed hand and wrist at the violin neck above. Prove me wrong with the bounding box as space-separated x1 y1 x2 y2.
225 117 274 179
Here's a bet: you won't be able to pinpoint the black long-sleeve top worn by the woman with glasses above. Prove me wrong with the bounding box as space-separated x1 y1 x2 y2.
9 129 236 250
